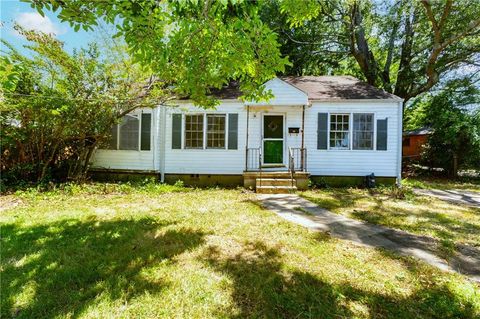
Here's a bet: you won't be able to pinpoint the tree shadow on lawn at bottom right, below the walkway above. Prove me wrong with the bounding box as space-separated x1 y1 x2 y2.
201 241 476 318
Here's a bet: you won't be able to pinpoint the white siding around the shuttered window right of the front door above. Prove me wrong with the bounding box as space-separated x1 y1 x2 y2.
305 102 401 177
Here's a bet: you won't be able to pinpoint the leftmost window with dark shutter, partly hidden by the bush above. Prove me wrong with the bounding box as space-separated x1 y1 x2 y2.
105 113 152 151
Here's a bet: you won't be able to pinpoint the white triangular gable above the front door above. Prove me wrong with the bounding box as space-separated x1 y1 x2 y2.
245 78 309 106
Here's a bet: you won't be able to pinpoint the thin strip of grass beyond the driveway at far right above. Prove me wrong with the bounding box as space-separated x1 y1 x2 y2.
402 177 480 192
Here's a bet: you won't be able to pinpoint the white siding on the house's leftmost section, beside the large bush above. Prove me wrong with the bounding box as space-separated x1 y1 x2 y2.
92 109 158 171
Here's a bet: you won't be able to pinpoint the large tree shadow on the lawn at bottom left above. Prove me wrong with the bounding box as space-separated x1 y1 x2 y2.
1 217 204 318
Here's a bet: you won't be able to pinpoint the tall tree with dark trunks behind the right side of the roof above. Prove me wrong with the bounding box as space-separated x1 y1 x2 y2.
263 0 480 101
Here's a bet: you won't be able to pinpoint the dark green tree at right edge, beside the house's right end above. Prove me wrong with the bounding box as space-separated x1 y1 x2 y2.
406 78 480 176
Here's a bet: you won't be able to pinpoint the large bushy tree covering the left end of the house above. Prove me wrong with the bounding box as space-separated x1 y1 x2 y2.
0 27 159 183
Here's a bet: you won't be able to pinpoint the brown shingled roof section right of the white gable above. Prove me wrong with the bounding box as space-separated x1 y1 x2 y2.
281 76 401 100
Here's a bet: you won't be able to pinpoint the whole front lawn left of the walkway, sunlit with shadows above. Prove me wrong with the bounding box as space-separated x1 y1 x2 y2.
0 184 480 318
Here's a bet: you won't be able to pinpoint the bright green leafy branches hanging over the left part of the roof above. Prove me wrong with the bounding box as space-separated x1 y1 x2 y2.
24 0 287 107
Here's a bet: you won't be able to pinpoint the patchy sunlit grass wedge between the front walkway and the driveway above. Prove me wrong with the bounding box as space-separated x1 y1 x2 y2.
301 188 480 253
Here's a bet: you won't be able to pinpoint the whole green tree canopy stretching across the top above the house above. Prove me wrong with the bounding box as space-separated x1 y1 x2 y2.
28 0 480 105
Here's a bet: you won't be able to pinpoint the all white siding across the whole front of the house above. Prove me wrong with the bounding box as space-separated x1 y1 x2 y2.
93 96 401 177
